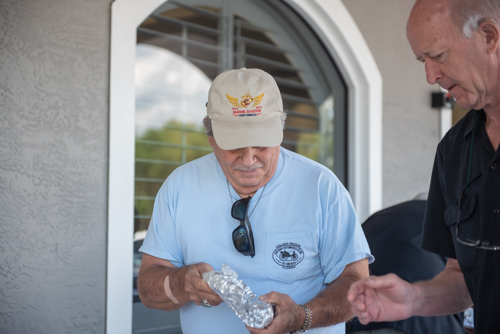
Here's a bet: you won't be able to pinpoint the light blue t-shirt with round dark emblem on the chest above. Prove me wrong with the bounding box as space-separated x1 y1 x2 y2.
140 148 373 334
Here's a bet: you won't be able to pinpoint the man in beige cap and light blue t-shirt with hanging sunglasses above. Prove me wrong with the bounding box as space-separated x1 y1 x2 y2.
138 68 372 334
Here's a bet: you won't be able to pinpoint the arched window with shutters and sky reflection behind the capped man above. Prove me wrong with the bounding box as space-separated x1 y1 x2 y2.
134 0 347 330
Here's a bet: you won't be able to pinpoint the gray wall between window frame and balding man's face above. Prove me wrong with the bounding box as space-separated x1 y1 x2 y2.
343 0 440 207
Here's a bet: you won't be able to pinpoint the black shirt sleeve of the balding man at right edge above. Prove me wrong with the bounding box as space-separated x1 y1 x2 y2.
421 145 456 259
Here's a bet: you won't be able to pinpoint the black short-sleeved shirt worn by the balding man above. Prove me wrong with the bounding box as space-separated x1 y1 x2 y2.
422 110 500 334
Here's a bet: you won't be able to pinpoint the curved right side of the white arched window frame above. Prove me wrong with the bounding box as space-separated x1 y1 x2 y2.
285 0 382 222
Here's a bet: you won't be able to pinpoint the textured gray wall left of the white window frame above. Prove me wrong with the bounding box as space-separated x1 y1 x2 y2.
0 0 111 334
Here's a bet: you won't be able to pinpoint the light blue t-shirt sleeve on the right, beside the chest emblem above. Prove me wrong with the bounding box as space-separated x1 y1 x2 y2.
319 180 375 284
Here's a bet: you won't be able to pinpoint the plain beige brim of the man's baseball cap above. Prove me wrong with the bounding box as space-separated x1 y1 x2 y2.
212 117 283 150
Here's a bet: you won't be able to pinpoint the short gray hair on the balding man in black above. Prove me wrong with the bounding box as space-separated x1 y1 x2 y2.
456 0 500 38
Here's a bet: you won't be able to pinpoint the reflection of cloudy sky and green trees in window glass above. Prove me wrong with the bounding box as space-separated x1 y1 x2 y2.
134 44 212 232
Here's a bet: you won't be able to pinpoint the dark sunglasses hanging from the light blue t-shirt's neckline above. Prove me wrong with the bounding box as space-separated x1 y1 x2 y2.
231 196 255 257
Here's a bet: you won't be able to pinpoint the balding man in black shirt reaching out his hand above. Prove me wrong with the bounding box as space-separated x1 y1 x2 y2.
348 0 500 333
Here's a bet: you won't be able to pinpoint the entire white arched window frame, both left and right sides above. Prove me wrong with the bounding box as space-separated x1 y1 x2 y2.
106 0 382 334
